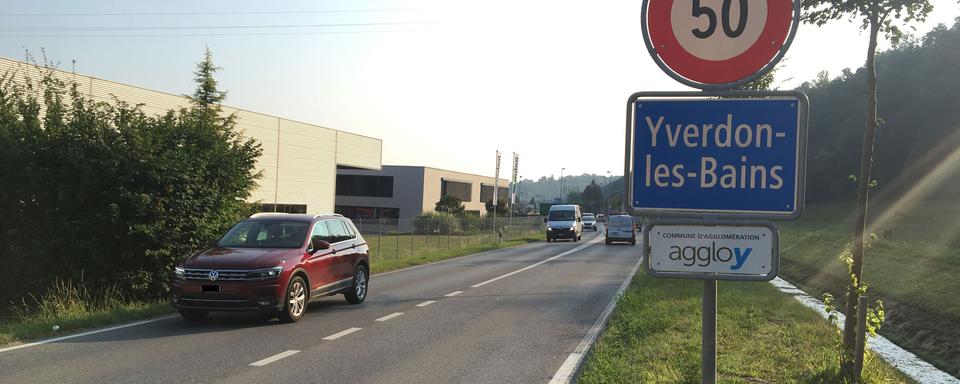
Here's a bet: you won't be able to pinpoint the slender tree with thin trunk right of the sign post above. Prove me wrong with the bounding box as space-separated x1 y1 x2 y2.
802 0 933 381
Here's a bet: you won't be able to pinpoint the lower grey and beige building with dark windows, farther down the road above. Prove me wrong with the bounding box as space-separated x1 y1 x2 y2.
335 165 508 219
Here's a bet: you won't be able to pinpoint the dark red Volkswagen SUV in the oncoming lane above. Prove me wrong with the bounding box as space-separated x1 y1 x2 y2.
170 213 370 322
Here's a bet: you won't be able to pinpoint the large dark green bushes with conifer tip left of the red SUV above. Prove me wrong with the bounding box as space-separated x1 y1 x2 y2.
0 52 261 315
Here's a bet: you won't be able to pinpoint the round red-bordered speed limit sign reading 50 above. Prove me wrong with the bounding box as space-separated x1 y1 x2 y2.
641 0 800 89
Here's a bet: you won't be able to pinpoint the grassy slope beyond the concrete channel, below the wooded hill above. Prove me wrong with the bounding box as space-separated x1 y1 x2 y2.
780 201 960 376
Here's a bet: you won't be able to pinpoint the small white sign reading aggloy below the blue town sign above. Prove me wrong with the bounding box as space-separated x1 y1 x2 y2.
643 222 780 281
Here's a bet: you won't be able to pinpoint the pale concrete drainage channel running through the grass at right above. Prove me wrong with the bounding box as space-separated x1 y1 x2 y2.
770 277 960 384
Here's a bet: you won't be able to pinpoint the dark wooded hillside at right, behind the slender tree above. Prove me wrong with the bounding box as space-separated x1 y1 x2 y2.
800 19 960 202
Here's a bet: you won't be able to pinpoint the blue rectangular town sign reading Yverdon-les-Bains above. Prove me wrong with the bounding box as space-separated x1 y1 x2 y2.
625 92 807 219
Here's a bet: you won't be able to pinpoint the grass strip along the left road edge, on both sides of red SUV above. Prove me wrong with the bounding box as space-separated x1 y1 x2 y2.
0 232 541 347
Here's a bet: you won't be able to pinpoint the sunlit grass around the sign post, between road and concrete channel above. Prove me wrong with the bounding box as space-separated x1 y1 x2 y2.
579 273 911 384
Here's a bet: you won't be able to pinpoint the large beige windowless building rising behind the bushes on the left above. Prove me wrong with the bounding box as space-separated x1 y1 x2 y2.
0 58 382 213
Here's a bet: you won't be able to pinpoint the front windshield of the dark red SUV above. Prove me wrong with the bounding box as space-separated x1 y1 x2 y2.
217 220 310 248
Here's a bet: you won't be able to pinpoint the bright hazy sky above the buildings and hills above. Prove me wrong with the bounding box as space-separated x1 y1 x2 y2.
0 0 960 179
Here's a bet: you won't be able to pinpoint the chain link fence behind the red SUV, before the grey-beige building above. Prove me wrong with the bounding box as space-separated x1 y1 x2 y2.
353 216 544 258
